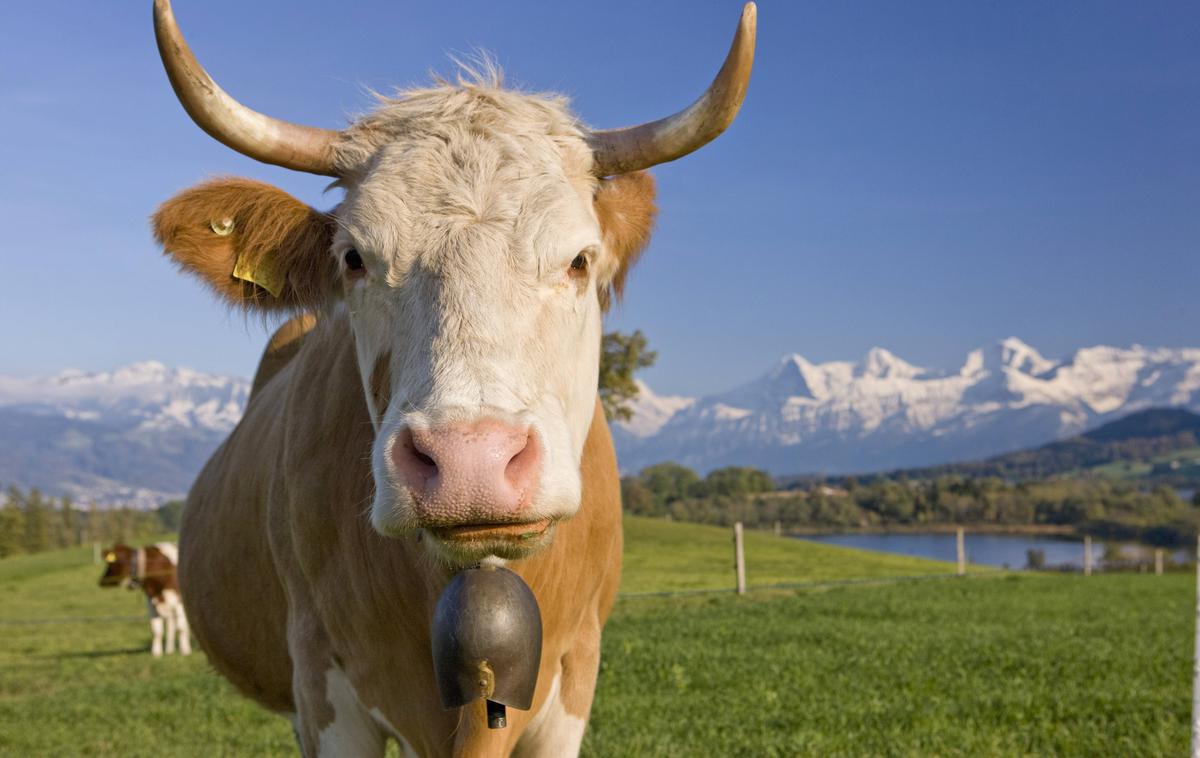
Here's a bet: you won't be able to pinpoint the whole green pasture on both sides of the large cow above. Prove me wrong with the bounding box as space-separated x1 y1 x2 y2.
0 518 1195 758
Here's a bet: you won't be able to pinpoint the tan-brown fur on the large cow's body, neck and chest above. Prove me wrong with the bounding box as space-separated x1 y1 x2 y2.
180 315 622 756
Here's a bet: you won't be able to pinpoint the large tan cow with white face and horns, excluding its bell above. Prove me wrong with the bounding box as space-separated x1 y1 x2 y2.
145 0 756 757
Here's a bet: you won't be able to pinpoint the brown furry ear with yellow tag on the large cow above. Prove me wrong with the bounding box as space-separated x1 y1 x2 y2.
152 179 337 311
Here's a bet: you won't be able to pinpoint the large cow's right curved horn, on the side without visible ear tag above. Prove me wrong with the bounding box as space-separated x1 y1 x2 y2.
588 2 758 176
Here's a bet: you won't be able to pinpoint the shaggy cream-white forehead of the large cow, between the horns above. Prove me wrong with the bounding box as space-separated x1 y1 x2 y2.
338 88 598 260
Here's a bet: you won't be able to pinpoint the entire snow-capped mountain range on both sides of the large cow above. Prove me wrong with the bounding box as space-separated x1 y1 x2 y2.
0 338 1200 507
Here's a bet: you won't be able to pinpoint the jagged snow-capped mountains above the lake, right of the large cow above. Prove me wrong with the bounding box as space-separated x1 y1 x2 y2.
614 337 1200 474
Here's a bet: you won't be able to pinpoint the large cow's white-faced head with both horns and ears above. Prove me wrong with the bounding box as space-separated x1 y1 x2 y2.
147 0 755 563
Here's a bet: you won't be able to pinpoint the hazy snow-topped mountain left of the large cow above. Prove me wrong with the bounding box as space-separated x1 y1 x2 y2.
0 361 250 507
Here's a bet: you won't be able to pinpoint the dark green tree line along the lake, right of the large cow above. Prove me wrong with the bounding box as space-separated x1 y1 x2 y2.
622 463 1200 546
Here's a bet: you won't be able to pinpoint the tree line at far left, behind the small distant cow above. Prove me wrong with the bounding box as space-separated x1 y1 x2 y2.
0 487 184 558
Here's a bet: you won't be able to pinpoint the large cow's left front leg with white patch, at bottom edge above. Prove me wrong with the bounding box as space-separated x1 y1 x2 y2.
288 624 386 758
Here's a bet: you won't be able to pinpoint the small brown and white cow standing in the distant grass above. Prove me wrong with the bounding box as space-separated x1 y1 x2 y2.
100 542 192 658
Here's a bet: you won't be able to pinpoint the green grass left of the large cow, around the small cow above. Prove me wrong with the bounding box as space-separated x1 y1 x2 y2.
0 548 295 757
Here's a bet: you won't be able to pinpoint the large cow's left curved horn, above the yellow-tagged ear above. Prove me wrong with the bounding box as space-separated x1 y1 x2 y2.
154 0 338 176
